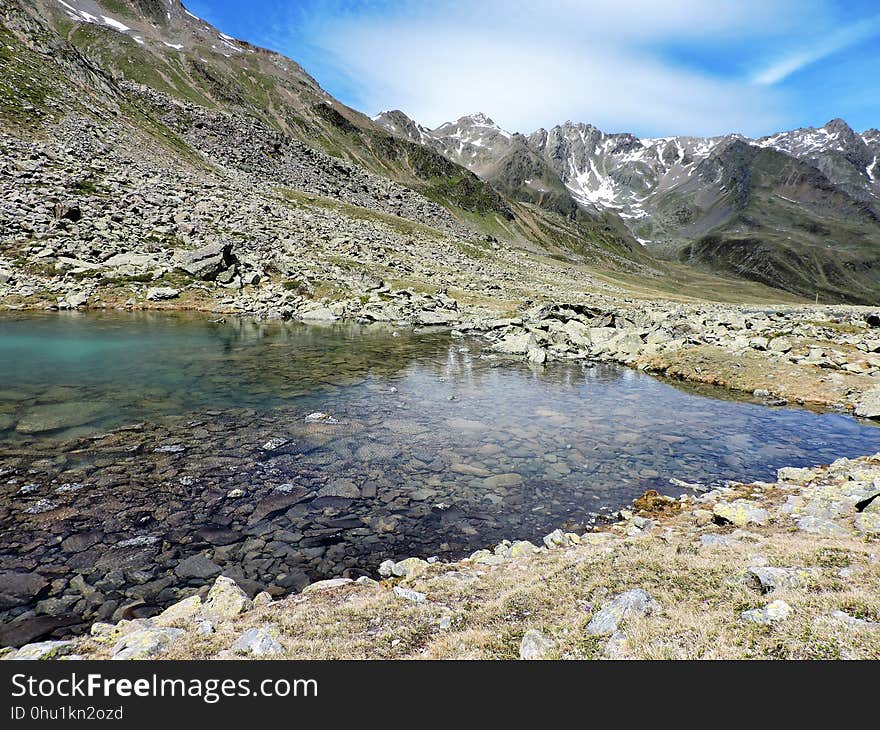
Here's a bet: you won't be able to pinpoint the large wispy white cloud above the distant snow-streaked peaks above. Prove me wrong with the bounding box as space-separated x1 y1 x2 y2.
291 0 872 135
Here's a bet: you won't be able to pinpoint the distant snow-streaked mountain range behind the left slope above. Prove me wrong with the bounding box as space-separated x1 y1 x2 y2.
375 111 880 303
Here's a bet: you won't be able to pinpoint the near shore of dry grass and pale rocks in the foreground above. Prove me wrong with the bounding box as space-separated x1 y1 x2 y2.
4 454 880 660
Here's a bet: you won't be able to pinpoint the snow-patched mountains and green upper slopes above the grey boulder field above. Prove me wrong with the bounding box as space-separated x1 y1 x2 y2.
0 0 880 303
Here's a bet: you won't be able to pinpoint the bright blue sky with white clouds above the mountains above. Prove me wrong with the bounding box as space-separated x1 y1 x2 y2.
184 0 880 136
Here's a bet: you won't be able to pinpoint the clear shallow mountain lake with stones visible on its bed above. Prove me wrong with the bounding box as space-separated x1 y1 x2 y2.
0 314 880 640
